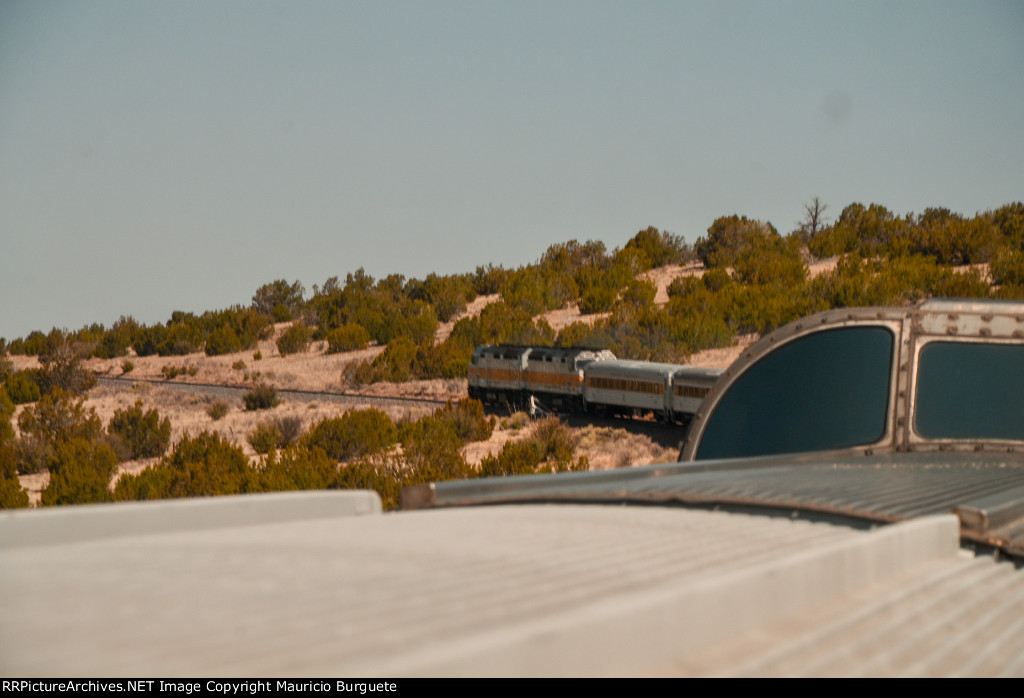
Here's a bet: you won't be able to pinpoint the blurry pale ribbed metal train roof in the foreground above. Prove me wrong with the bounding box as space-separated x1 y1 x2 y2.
8 492 1024 677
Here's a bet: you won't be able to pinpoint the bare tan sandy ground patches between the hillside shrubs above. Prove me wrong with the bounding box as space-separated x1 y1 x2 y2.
11 265 757 506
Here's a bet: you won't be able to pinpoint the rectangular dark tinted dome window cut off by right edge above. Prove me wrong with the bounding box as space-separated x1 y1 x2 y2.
913 342 1024 439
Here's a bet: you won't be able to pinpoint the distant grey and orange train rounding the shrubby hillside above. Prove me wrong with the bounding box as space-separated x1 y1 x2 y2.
468 344 722 425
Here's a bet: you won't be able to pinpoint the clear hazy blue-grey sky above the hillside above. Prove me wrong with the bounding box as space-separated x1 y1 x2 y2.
0 0 1024 340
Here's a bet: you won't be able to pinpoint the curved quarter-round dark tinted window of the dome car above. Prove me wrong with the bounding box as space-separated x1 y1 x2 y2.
696 326 893 460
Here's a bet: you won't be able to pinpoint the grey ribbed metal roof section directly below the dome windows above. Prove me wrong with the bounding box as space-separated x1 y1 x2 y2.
403 452 1024 555
